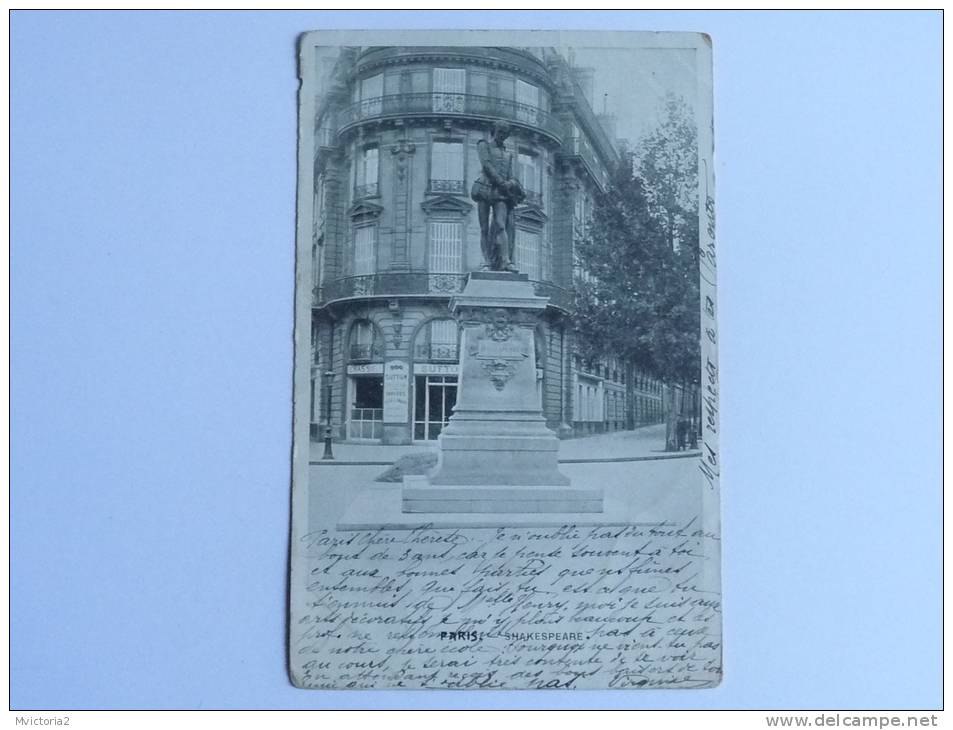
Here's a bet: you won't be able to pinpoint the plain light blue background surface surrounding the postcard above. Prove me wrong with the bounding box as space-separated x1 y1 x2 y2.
11 12 941 709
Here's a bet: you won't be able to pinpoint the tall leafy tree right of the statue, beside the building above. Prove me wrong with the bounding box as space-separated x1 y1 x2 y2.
575 97 701 449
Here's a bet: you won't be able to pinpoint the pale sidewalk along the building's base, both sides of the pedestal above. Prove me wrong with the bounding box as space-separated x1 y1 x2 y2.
311 423 699 466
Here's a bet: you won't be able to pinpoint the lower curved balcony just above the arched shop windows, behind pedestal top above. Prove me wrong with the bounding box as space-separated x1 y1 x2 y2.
314 273 574 312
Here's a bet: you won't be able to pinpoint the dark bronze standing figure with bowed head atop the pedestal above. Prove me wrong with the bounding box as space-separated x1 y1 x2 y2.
470 122 526 272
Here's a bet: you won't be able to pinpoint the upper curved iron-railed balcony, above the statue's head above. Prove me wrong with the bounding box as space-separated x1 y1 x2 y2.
337 92 563 144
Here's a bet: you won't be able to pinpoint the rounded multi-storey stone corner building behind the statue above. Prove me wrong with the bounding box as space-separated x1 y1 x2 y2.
311 46 660 444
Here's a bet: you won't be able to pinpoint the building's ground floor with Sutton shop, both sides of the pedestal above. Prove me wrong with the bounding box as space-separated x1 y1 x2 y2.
310 302 661 444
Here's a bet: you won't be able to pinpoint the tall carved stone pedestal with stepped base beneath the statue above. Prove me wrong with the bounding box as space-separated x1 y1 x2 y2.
402 272 602 513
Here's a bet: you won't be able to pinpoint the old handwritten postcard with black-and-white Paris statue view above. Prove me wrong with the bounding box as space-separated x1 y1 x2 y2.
289 31 722 689
